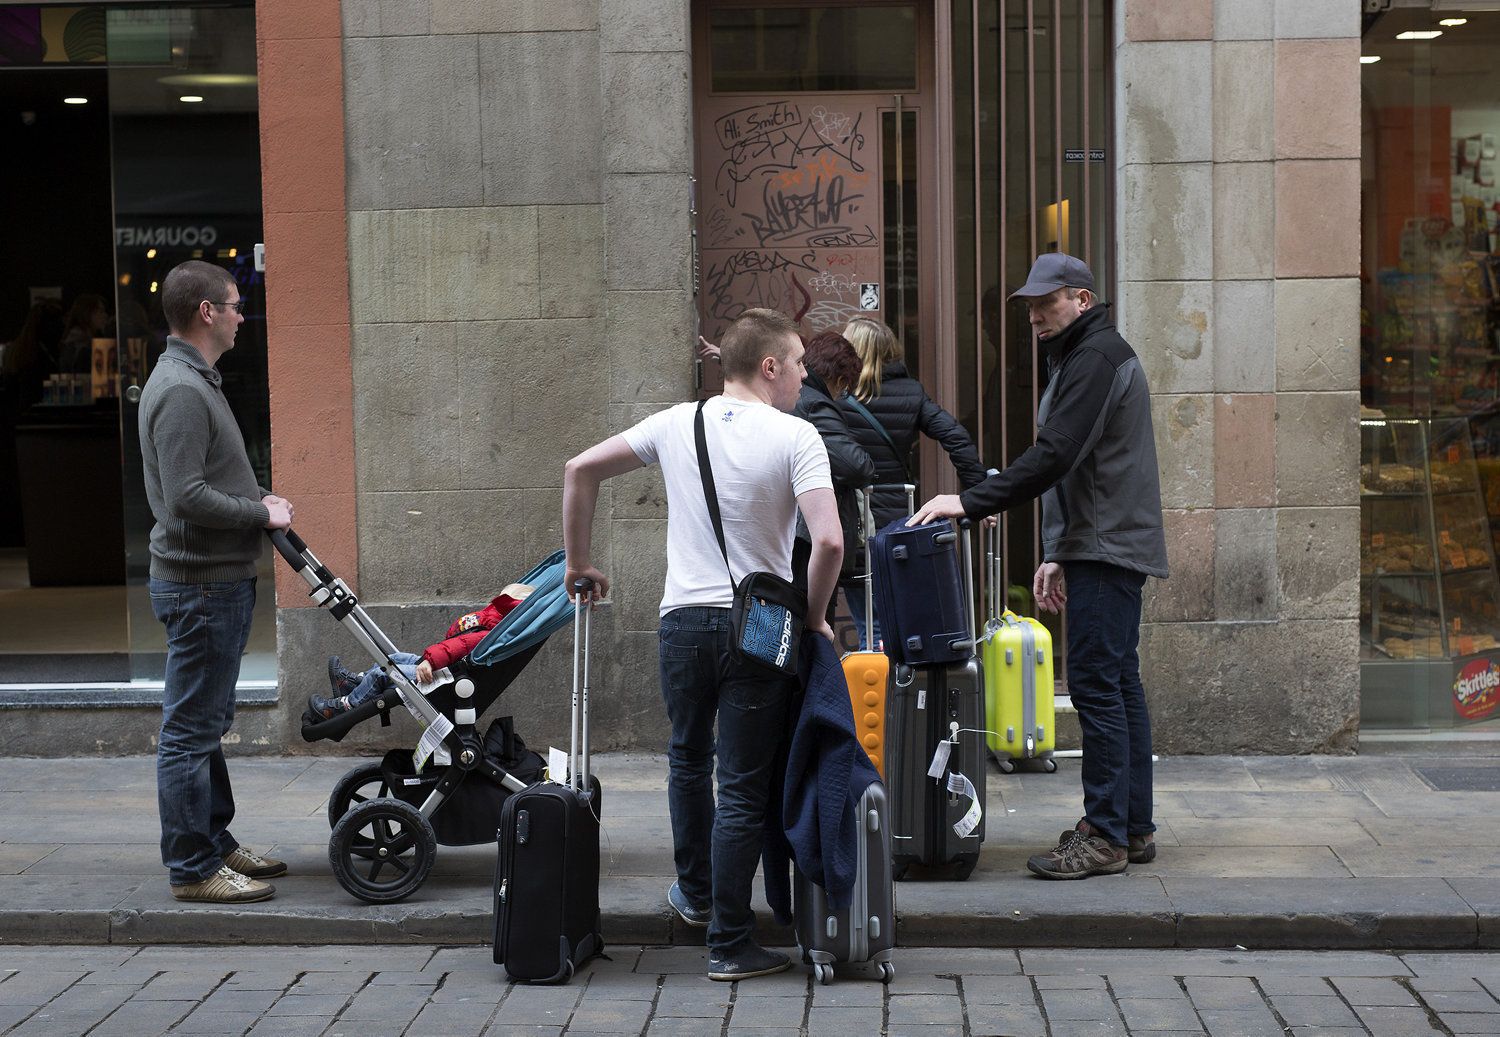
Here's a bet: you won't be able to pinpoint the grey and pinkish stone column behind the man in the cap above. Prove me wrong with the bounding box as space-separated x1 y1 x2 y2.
1116 0 1361 753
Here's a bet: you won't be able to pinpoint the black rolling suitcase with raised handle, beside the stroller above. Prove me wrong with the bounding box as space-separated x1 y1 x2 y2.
494 587 605 983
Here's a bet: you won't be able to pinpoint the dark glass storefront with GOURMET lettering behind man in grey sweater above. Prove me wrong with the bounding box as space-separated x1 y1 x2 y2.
0 6 276 686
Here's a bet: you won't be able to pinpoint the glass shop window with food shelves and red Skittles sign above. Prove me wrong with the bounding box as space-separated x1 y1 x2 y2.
1361 9 1500 728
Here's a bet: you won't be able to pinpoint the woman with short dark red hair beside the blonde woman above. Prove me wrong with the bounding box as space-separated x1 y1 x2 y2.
792 332 875 624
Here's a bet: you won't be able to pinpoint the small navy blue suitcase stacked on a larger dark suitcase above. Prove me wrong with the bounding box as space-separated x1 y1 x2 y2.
870 519 974 666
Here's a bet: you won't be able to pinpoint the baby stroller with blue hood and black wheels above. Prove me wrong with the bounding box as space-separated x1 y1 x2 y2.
270 530 573 903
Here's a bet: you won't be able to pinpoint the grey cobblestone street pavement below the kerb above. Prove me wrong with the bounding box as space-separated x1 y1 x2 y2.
0 945 1500 1037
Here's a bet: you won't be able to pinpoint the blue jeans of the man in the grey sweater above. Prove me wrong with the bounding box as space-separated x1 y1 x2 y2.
147 578 255 885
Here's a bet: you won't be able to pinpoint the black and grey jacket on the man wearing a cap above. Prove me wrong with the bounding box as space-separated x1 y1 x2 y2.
960 306 1167 579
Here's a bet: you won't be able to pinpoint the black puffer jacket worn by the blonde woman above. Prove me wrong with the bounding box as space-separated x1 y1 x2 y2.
839 363 984 530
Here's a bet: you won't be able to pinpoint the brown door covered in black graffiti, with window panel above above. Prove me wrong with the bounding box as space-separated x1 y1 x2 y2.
693 0 933 392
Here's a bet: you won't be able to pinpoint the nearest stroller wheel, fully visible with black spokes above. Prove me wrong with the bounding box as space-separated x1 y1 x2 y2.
329 798 438 903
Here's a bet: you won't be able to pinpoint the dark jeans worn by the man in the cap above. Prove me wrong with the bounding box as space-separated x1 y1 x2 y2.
1062 561 1157 846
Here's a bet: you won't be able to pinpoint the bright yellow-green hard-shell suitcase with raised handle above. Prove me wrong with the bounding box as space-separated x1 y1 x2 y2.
981 537 1058 771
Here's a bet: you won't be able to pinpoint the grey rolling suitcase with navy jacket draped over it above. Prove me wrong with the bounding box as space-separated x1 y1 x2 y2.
792 782 896 983
